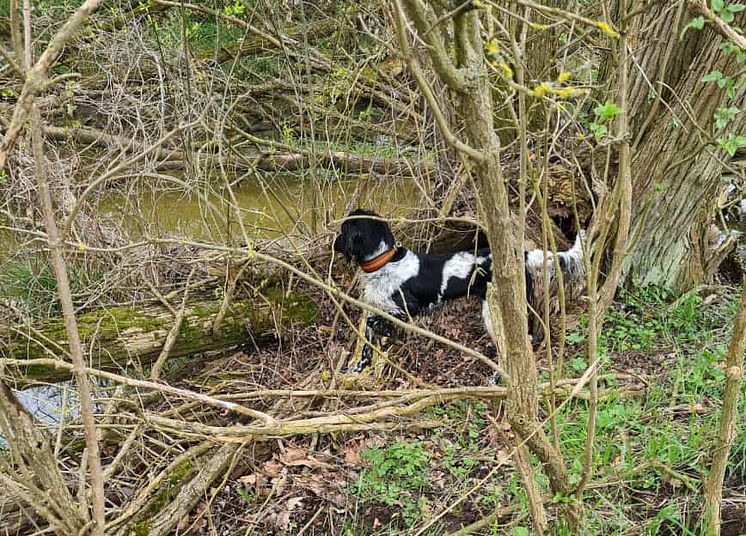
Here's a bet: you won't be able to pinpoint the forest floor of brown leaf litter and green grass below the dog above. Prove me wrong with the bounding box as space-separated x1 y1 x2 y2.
158 278 746 536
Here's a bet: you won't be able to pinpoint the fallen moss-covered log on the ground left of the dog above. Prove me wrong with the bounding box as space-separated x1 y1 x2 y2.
0 287 316 384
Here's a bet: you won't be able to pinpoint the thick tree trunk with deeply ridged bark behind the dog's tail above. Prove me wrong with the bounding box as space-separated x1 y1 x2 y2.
602 3 746 289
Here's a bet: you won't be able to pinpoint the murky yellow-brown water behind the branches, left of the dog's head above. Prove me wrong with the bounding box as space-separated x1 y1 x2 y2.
99 176 419 240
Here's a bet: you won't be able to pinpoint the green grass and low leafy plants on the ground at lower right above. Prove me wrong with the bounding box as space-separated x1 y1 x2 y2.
350 289 746 536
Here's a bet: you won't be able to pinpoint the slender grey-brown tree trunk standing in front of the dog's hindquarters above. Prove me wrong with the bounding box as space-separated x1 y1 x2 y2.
395 0 577 532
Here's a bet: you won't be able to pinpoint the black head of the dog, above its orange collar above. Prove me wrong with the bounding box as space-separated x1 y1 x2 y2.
334 209 394 264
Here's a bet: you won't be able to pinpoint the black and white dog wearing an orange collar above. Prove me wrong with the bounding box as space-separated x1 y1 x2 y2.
334 209 584 372
